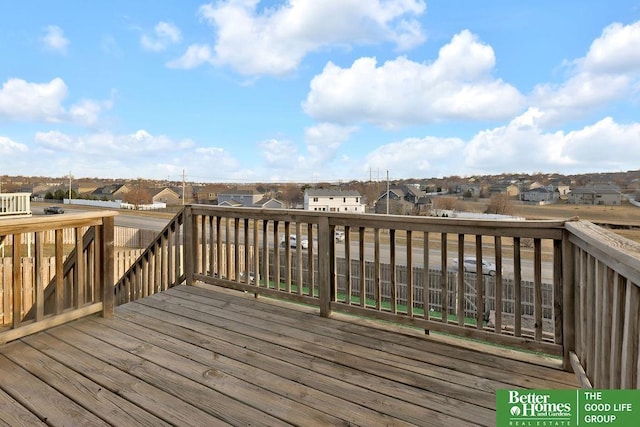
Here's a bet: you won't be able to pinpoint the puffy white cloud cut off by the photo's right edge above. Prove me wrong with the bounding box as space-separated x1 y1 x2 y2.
530 21 640 126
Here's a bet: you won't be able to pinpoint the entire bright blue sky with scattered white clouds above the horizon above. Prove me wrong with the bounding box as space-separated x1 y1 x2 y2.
0 0 640 182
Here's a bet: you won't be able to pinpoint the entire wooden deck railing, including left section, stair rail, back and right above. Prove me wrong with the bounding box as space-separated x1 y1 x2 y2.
0 205 640 388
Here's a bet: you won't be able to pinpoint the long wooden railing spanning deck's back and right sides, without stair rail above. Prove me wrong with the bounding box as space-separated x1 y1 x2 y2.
174 205 640 388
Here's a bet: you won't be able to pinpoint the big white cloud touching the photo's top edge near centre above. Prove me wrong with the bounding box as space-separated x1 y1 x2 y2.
188 0 426 75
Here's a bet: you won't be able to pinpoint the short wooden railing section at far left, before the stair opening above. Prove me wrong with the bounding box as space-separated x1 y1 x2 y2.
0 212 116 343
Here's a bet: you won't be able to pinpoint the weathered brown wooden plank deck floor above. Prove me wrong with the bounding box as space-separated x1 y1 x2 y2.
0 286 579 426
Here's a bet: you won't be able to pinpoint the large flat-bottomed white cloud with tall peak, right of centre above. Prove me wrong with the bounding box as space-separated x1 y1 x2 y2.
303 30 523 127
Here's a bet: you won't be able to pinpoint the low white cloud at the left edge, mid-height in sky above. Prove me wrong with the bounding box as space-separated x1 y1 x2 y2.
0 77 113 126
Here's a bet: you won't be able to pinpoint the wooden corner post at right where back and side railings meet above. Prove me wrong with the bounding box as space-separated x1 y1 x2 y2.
562 228 576 371
